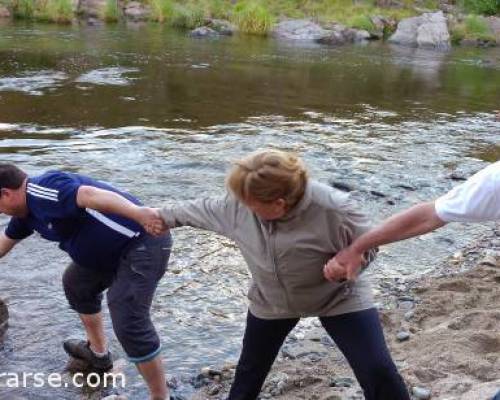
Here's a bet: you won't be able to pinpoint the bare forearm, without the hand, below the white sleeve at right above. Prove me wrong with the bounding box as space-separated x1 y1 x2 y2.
351 203 445 253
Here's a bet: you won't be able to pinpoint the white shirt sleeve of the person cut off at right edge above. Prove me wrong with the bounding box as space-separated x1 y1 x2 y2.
435 161 500 222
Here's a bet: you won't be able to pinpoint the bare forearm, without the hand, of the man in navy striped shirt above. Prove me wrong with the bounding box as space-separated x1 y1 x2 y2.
77 186 141 222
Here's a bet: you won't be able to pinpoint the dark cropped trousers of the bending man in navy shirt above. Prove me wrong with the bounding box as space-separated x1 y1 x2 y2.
63 235 172 363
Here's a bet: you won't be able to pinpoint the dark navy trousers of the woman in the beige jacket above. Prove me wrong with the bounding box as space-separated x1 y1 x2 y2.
228 309 410 400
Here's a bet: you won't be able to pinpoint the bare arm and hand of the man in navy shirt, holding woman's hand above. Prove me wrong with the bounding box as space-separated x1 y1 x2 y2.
76 186 161 232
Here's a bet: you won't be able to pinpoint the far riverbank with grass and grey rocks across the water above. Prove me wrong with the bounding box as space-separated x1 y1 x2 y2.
0 0 500 50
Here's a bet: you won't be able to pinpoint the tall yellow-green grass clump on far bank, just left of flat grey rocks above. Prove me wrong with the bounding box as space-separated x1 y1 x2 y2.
232 0 274 35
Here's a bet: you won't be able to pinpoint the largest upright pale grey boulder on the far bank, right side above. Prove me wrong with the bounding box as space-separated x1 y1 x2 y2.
389 11 451 49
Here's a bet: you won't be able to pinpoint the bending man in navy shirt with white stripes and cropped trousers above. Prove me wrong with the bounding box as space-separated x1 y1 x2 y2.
0 164 172 400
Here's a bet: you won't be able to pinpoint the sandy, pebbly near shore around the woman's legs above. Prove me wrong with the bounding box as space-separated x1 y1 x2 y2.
186 227 500 400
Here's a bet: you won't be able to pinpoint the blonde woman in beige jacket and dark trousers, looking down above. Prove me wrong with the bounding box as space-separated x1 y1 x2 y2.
150 150 409 400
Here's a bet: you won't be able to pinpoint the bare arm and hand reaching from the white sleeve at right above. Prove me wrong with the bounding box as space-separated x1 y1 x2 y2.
324 202 446 280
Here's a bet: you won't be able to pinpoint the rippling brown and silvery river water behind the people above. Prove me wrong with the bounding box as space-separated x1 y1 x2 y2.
0 24 500 399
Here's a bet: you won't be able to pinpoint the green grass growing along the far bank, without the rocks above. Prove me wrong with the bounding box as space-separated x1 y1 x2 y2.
0 0 500 36
